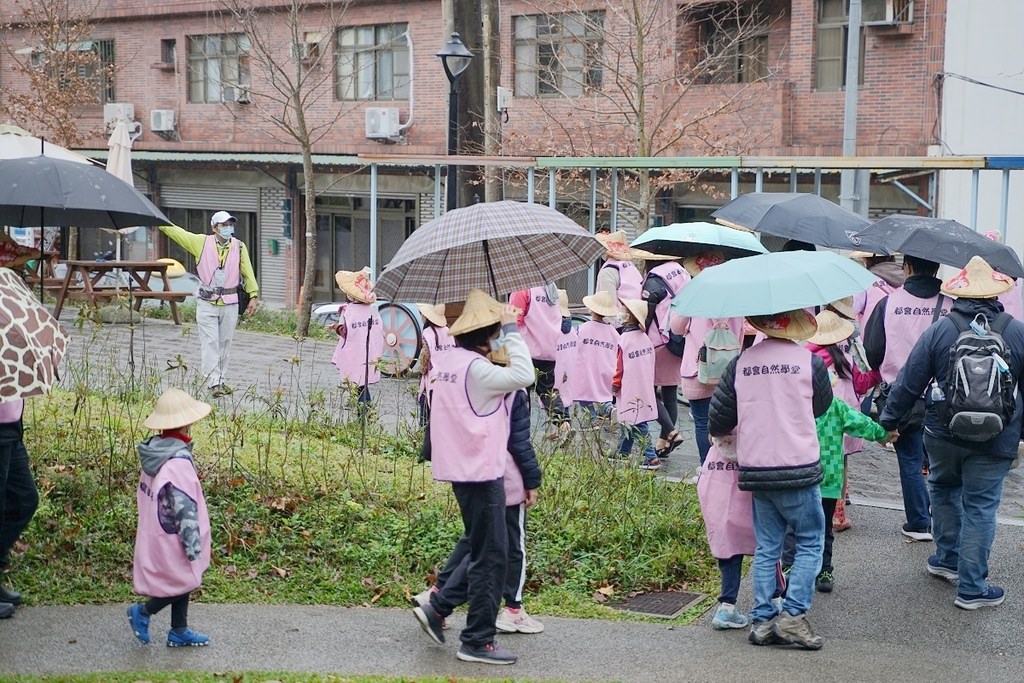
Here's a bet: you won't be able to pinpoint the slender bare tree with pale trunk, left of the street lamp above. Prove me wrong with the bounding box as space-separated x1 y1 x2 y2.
217 0 351 336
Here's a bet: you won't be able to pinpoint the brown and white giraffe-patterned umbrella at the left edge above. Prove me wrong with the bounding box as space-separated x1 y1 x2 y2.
0 268 70 401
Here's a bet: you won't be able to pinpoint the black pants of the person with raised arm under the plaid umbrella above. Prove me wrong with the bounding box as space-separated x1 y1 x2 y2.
430 479 508 647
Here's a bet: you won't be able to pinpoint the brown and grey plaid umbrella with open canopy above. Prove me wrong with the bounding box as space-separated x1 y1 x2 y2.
374 201 604 303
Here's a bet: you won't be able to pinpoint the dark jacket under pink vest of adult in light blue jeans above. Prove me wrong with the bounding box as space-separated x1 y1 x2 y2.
708 351 833 490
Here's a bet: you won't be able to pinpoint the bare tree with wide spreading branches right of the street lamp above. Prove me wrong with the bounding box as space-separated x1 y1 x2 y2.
505 0 776 230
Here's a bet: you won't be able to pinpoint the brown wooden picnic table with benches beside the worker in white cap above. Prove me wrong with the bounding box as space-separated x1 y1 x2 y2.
53 261 190 325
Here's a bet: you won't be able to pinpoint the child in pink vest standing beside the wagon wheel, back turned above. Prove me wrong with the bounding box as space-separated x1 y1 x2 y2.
331 270 384 408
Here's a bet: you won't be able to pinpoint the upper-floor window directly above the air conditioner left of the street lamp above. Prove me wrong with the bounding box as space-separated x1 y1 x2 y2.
336 24 411 100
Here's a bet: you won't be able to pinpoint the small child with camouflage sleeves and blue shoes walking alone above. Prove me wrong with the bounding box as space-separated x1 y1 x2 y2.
128 389 211 647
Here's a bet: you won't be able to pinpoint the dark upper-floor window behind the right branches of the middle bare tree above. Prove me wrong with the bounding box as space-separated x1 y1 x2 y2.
695 4 768 83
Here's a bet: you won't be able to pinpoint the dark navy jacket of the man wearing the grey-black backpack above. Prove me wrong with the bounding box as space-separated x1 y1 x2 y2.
879 299 1024 458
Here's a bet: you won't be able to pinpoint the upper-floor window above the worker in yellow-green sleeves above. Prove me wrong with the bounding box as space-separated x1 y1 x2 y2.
188 33 251 102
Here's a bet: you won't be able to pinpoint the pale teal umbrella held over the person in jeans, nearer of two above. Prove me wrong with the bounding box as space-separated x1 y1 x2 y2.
672 251 877 317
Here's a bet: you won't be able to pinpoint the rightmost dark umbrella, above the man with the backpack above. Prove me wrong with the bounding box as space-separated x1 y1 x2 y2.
858 214 1024 278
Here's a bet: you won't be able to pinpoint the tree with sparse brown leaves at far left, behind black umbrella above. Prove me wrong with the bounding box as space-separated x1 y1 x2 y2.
0 0 115 258
